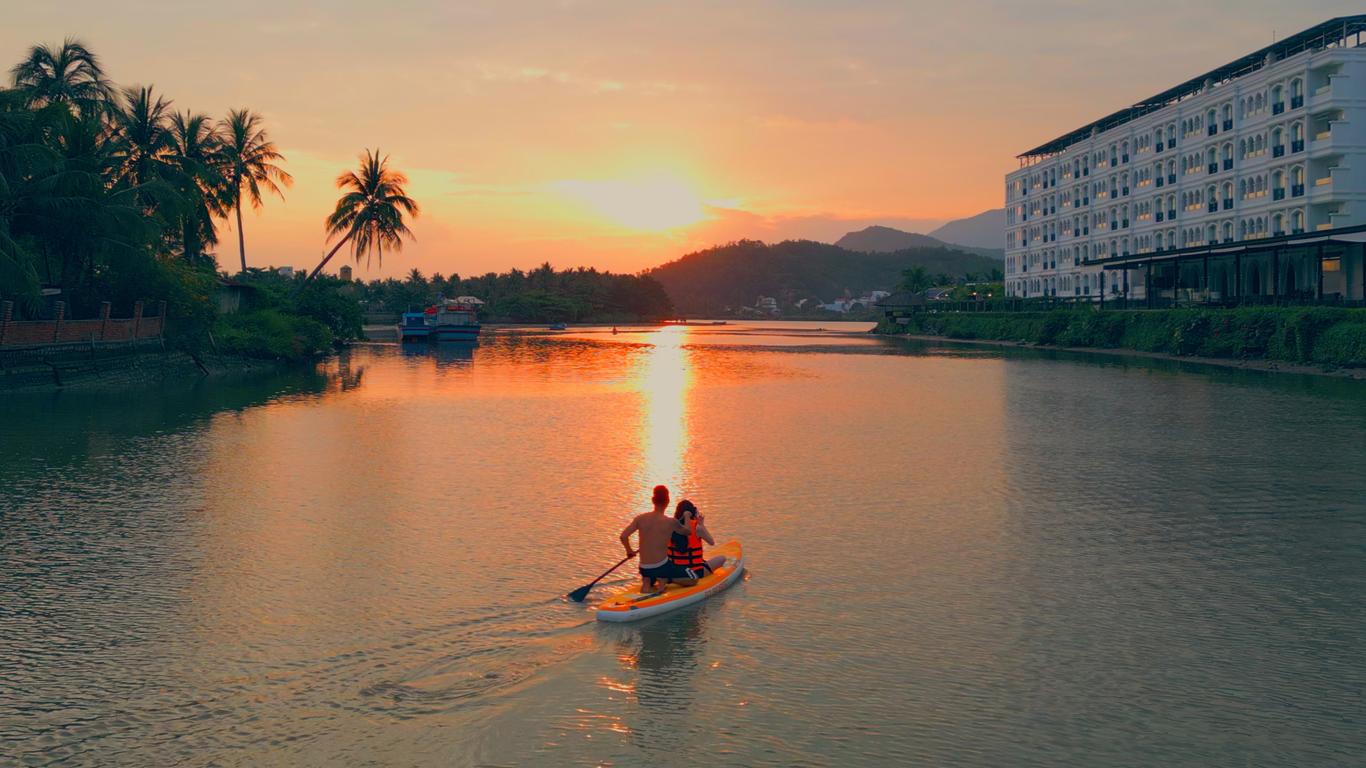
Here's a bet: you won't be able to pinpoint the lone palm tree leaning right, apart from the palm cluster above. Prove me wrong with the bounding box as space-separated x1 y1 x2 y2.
305 149 421 283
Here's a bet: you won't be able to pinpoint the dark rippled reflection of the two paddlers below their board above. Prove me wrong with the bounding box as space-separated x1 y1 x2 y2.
619 607 706 754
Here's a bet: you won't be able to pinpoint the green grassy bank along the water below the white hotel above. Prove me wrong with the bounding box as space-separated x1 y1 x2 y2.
877 307 1366 366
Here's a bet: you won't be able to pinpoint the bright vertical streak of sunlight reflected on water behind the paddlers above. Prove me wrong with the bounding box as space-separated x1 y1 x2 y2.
632 325 693 489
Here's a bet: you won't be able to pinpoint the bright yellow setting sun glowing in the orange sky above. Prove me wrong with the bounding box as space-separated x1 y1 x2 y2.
555 174 709 232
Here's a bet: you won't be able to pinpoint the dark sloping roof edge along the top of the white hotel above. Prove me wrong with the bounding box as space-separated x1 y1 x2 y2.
1016 15 1366 160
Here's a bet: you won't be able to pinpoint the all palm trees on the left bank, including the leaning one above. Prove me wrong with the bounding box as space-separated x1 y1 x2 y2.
0 38 418 337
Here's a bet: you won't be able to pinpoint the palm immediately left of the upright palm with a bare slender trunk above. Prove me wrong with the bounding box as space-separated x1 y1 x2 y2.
171 112 229 262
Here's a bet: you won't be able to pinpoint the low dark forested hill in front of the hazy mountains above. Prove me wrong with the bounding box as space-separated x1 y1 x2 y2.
649 235 1001 314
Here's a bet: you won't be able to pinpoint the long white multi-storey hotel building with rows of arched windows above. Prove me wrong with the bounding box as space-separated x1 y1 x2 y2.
1005 16 1366 305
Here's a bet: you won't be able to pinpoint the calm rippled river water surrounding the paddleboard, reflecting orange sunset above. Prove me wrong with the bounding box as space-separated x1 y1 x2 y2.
0 319 1366 767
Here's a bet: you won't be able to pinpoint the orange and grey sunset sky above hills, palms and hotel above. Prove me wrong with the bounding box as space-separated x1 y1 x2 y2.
0 0 1359 279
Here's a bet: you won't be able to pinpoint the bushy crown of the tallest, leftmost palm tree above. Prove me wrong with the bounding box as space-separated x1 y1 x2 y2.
10 37 113 115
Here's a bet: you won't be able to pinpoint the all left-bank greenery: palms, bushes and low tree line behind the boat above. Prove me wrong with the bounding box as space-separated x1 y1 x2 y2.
0 38 673 361
